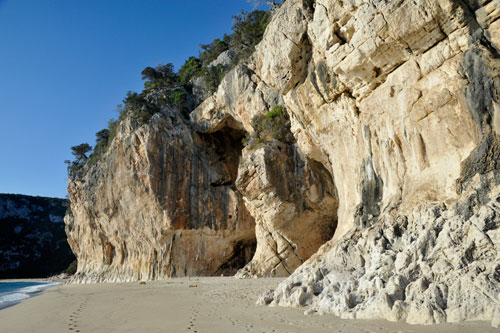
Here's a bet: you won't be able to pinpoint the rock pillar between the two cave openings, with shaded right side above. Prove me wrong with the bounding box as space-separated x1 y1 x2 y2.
236 142 338 277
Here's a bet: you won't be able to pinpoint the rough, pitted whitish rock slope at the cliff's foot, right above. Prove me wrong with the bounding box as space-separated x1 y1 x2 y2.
259 174 500 326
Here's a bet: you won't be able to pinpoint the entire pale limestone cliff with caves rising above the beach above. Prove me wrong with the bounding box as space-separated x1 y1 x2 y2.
67 0 500 325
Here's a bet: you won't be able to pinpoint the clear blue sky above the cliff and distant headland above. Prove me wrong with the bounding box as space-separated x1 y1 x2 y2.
0 0 266 197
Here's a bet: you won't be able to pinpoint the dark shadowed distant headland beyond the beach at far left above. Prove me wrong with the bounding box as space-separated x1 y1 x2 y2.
0 194 75 279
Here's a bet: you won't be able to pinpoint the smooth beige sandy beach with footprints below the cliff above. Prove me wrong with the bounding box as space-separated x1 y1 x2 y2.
0 277 499 333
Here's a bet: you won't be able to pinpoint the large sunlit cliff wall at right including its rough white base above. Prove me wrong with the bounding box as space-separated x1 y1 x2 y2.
235 0 500 325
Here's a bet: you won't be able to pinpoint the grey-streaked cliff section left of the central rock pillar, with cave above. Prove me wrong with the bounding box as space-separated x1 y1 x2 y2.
66 110 256 282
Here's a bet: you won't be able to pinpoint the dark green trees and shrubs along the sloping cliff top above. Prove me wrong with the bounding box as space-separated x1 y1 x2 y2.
65 5 280 178
